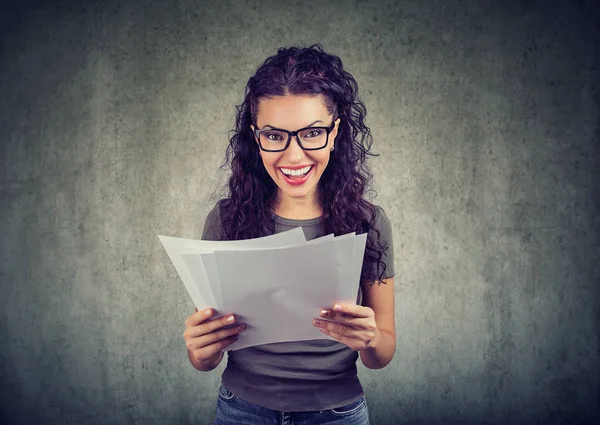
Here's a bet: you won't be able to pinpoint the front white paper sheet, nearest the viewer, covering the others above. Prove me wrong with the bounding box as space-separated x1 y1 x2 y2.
214 234 366 350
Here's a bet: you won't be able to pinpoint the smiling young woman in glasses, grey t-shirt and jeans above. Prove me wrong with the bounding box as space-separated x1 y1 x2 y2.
183 44 396 425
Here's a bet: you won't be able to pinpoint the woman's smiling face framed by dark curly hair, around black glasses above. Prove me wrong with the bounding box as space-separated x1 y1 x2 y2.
250 95 340 210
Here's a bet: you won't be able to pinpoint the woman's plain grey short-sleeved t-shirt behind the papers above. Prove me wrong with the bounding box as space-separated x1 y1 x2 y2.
202 200 394 412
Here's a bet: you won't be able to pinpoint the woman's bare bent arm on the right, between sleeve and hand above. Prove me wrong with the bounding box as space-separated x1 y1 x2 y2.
359 277 396 369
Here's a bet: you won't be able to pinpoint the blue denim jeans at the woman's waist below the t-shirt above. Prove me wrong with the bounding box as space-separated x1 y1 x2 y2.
215 384 369 425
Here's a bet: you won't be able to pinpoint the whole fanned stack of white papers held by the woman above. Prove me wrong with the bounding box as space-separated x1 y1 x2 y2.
158 227 367 350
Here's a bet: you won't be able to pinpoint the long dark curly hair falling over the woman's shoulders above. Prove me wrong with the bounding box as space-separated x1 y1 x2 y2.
213 44 388 284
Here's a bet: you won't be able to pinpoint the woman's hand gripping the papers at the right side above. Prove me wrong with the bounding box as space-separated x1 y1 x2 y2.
313 303 379 351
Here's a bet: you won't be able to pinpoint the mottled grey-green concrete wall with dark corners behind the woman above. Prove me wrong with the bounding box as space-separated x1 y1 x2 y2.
0 0 600 424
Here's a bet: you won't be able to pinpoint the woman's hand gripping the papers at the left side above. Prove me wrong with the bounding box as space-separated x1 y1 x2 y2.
183 308 246 367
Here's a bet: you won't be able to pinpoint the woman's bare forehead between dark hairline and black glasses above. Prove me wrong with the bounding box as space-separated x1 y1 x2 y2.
256 95 329 128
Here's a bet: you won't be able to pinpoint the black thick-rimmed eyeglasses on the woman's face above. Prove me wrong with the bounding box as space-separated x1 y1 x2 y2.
254 120 335 152
